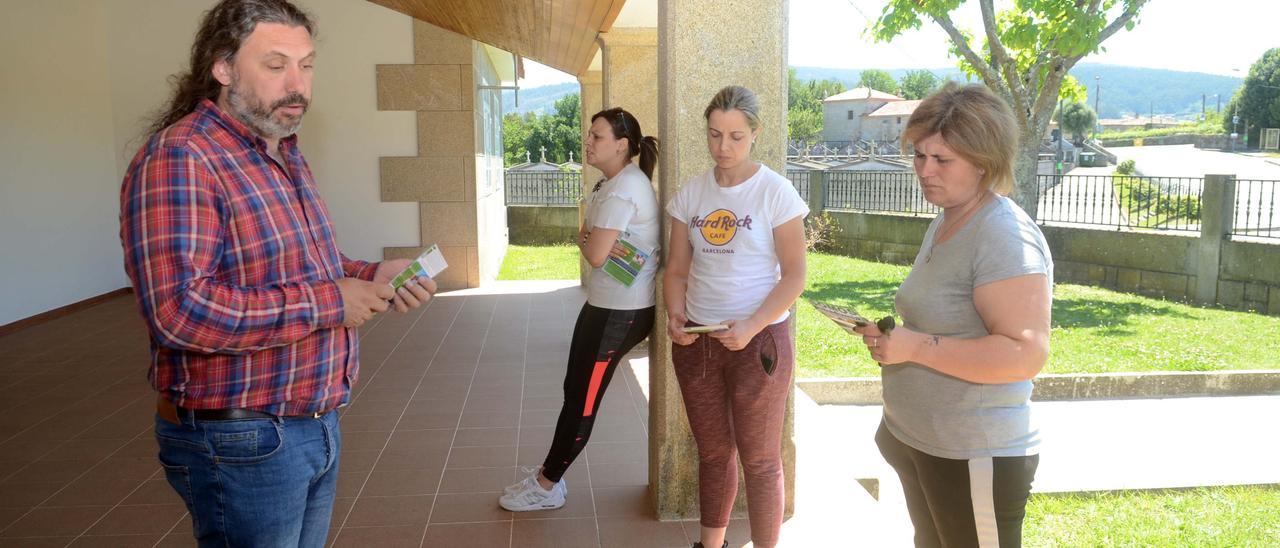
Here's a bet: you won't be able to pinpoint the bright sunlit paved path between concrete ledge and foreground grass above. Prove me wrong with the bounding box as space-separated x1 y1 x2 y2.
803 392 1280 547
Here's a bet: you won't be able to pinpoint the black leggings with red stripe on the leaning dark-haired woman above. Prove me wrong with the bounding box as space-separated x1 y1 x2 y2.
543 305 654 481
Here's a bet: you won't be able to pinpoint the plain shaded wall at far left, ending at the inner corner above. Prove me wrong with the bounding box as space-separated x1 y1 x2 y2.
0 0 127 325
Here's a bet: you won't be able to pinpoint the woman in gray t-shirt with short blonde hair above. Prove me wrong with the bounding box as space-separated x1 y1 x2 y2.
859 83 1053 547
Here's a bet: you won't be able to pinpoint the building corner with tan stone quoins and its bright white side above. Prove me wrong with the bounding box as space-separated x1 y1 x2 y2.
376 20 507 289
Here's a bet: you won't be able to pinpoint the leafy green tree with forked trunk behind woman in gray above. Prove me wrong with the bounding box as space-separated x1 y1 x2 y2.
870 0 1147 218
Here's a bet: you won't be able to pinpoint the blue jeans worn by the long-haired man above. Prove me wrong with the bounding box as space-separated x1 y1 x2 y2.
156 411 342 547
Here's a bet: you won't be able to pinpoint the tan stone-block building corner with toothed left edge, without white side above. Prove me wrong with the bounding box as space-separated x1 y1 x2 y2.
376 20 483 289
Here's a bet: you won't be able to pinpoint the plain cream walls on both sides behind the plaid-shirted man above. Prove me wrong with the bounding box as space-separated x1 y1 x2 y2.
0 0 419 325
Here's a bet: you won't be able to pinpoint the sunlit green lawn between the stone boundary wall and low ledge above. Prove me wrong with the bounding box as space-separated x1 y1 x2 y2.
500 246 1280 378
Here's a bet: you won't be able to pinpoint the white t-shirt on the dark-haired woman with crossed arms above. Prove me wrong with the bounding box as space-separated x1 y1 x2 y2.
586 163 659 310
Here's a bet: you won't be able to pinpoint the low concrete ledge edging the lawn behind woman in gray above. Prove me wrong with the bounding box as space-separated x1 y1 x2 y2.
796 370 1280 405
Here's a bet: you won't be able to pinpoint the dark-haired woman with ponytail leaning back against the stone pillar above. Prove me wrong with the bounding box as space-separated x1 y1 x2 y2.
498 109 660 512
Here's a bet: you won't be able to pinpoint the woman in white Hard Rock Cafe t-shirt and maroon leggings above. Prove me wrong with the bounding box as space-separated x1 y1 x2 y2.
663 86 809 548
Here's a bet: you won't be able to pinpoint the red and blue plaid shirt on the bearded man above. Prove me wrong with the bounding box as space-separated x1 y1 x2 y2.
120 100 376 415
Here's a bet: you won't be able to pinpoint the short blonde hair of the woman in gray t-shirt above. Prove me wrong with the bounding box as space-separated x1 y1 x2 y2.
902 82 1018 196
